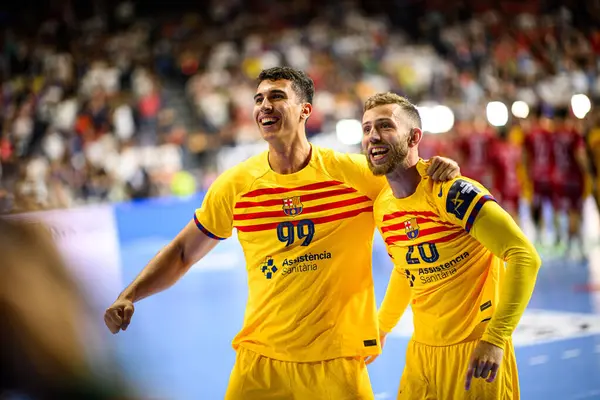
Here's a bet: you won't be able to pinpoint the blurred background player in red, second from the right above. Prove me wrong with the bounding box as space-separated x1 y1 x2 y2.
523 108 554 242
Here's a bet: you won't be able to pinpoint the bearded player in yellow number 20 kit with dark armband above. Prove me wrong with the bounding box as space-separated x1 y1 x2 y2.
363 93 540 400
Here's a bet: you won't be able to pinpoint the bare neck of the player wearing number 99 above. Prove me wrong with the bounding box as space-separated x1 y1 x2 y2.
269 136 312 175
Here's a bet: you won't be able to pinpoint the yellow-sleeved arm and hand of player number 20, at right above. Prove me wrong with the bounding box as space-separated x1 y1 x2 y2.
465 201 541 390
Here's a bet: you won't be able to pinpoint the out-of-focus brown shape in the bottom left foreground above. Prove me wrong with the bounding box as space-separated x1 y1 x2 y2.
0 218 134 400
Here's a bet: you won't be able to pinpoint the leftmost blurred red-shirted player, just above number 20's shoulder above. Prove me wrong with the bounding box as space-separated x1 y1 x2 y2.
457 117 494 187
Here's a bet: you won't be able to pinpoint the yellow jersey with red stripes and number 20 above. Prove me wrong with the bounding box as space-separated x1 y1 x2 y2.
374 161 504 346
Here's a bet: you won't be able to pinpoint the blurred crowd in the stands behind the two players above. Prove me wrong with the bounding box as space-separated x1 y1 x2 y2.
0 0 600 238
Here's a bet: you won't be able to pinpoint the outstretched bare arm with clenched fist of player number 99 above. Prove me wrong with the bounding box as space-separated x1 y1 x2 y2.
104 221 219 334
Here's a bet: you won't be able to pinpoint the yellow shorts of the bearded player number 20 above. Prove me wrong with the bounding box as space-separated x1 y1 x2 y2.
398 340 520 400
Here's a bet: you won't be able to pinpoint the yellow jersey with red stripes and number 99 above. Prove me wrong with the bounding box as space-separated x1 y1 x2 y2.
195 146 385 362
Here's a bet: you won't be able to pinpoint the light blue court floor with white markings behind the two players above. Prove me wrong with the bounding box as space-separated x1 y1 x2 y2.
109 198 600 400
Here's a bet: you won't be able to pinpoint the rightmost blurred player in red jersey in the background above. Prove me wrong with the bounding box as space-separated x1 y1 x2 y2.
552 108 588 254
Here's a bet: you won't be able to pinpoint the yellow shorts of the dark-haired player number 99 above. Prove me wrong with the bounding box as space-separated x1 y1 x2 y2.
225 347 374 400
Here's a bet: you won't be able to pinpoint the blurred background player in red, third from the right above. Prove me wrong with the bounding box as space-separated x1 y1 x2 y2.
490 127 523 223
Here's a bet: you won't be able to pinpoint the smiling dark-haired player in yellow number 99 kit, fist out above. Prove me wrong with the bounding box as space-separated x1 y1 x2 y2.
105 68 458 400
